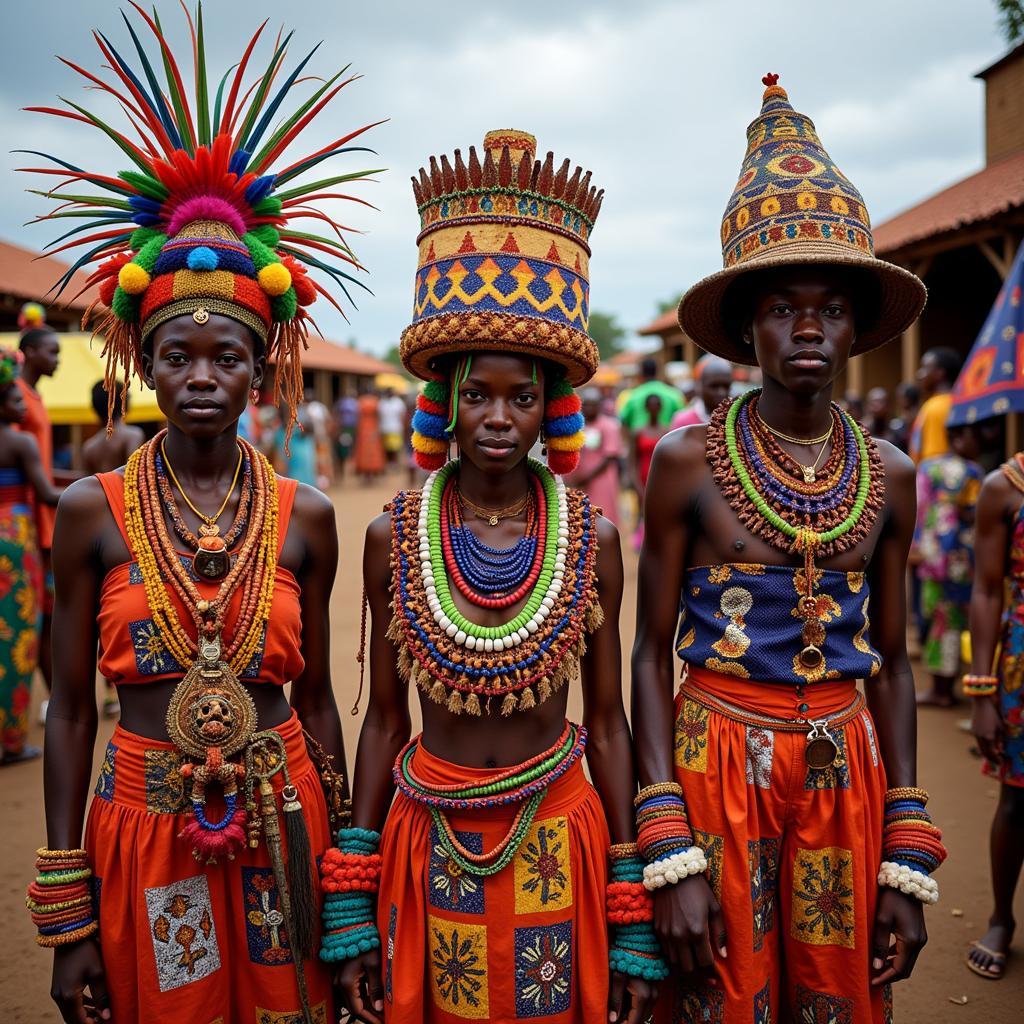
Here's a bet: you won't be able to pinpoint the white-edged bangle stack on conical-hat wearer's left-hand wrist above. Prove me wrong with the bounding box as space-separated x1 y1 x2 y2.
634 782 708 892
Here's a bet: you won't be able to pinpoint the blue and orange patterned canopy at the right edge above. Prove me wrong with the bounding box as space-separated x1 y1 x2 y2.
949 242 1024 427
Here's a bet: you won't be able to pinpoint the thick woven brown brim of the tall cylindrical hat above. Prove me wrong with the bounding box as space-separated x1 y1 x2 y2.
398 312 599 387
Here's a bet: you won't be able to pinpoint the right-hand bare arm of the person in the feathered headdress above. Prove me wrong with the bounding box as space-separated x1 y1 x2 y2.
292 483 349 798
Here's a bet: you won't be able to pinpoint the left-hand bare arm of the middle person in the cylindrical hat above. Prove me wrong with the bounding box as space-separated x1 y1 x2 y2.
352 514 413 831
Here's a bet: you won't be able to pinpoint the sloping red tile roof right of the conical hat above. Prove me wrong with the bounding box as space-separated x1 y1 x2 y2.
874 153 1024 255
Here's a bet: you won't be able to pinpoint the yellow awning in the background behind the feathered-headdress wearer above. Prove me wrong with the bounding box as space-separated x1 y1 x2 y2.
0 332 164 425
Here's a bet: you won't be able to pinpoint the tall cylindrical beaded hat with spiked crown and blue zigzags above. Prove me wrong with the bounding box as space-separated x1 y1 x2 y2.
400 130 603 387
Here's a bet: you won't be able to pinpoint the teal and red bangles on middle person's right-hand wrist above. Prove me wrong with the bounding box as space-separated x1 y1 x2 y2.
606 843 669 981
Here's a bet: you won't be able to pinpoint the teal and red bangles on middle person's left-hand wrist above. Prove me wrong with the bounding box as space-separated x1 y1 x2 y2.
321 828 381 964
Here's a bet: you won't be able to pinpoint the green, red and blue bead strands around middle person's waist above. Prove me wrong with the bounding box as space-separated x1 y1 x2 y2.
392 722 587 878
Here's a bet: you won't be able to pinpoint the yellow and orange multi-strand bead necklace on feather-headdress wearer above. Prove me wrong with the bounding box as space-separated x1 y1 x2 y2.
125 431 278 673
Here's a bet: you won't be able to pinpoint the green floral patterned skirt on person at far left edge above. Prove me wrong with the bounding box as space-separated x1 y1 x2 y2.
0 469 42 757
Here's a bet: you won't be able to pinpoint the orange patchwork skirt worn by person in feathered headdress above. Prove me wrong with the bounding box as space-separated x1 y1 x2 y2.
85 713 335 1024
